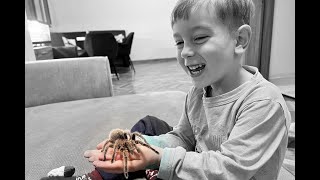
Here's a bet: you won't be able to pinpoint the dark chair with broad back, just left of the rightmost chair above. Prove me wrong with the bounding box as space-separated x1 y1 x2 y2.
84 32 119 80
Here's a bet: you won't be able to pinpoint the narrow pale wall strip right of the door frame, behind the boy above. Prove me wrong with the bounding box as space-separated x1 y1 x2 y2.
269 0 295 79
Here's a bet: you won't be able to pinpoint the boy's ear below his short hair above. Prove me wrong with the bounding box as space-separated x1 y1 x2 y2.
235 24 252 54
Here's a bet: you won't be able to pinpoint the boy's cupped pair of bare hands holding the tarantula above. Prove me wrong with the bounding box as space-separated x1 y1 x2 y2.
85 143 162 173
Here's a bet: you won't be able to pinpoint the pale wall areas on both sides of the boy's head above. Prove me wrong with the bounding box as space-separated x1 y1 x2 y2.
45 0 295 73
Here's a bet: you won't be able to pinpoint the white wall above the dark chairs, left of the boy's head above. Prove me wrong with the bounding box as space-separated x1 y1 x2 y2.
48 0 177 61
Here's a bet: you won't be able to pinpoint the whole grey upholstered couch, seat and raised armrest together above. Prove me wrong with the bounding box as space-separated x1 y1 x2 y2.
25 57 294 180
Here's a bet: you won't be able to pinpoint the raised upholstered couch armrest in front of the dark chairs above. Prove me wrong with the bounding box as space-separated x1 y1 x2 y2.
25 57 113 107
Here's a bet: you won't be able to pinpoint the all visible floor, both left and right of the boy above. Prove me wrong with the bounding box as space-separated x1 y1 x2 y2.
112 59 295 175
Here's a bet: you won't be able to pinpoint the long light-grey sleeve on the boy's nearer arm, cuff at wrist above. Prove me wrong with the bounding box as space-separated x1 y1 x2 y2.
158 100 288 180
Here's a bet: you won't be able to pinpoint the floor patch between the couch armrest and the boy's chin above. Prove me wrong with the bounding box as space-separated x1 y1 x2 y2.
112 59 191 96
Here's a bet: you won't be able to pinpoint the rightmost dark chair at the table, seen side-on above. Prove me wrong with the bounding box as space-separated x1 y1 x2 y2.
117 32 136 72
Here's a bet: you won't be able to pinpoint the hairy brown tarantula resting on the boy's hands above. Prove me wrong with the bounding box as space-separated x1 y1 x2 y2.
101 129 159 179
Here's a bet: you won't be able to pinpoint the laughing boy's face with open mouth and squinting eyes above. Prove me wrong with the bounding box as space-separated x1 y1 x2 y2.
172 8 236 88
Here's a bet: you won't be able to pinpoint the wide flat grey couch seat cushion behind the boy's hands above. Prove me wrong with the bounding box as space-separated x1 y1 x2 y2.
25 91 186 180
